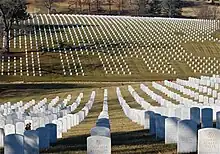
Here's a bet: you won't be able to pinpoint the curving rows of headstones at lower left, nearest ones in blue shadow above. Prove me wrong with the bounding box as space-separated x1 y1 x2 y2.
0 91 95 154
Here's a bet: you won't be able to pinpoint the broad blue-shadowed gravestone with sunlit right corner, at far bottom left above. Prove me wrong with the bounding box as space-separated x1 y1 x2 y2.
4 134 24 154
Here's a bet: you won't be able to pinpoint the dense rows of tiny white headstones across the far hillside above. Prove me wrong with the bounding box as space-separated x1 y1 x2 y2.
1 14 219 76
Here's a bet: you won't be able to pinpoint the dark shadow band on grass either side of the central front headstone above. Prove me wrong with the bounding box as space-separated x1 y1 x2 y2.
41 130 172 153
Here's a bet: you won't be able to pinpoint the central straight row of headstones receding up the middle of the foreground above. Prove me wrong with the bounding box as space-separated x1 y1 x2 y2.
87 89 111 154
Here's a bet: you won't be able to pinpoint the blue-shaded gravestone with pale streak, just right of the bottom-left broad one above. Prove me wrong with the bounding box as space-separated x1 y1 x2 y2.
24 130 39 154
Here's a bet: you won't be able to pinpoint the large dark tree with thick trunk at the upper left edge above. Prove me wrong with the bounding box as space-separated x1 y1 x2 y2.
0 0 30 53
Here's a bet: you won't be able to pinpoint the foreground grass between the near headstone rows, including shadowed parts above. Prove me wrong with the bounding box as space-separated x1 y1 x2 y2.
0 83 176 154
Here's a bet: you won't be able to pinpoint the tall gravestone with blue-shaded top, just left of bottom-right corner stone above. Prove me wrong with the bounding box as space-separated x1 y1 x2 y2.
177 120 197 153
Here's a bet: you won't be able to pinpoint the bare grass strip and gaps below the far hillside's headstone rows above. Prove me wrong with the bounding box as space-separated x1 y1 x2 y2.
0 41 220 82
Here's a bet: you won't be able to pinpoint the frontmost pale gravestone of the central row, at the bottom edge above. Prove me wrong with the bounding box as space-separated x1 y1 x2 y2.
87 136 111 154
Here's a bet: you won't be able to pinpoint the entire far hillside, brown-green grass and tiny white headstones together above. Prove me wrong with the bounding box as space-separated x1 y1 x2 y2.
0 14 220 81
